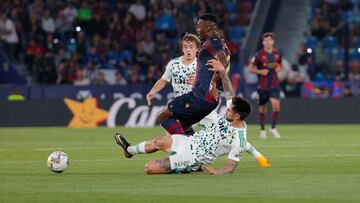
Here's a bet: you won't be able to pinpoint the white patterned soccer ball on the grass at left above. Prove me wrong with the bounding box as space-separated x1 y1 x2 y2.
48 151 69 173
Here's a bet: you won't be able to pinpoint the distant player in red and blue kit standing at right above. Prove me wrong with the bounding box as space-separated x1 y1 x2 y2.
248 32 281 139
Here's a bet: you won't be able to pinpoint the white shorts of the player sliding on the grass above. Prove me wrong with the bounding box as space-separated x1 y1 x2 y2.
169 134 199 173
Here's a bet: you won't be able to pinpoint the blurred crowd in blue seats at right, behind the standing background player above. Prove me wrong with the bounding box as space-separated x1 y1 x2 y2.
295 0 360 97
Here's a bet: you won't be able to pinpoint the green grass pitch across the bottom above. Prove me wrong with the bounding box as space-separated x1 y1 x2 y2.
0 125 360 203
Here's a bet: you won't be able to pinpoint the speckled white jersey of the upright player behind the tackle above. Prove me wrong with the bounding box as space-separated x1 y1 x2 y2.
161 57 197 97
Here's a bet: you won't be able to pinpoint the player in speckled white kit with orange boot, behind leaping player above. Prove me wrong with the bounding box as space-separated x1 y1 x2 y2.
146 34 269 167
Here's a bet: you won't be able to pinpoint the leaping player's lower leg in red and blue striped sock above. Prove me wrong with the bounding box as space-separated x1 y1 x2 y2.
158 107 184 134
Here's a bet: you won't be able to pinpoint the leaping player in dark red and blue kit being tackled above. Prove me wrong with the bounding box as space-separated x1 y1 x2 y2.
158 14 233 134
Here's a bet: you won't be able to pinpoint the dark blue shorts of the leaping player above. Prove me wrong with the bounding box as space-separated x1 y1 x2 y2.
167 92 218 127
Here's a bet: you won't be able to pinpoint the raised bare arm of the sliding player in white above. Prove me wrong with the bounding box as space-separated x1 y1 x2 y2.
206 59 234 100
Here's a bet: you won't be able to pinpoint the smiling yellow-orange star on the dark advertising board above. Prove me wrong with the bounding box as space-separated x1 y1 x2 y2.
64 98 108 128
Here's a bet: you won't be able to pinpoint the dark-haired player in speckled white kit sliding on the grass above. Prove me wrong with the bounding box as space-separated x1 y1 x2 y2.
115 97 251 174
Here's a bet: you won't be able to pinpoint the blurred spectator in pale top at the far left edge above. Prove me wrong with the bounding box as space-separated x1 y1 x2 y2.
0 12 19 57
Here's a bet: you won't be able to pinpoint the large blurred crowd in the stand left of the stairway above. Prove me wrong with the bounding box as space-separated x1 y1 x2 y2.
0 0 254 85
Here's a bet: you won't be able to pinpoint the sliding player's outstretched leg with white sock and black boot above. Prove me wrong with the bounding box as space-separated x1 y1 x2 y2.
115 134 172 158
